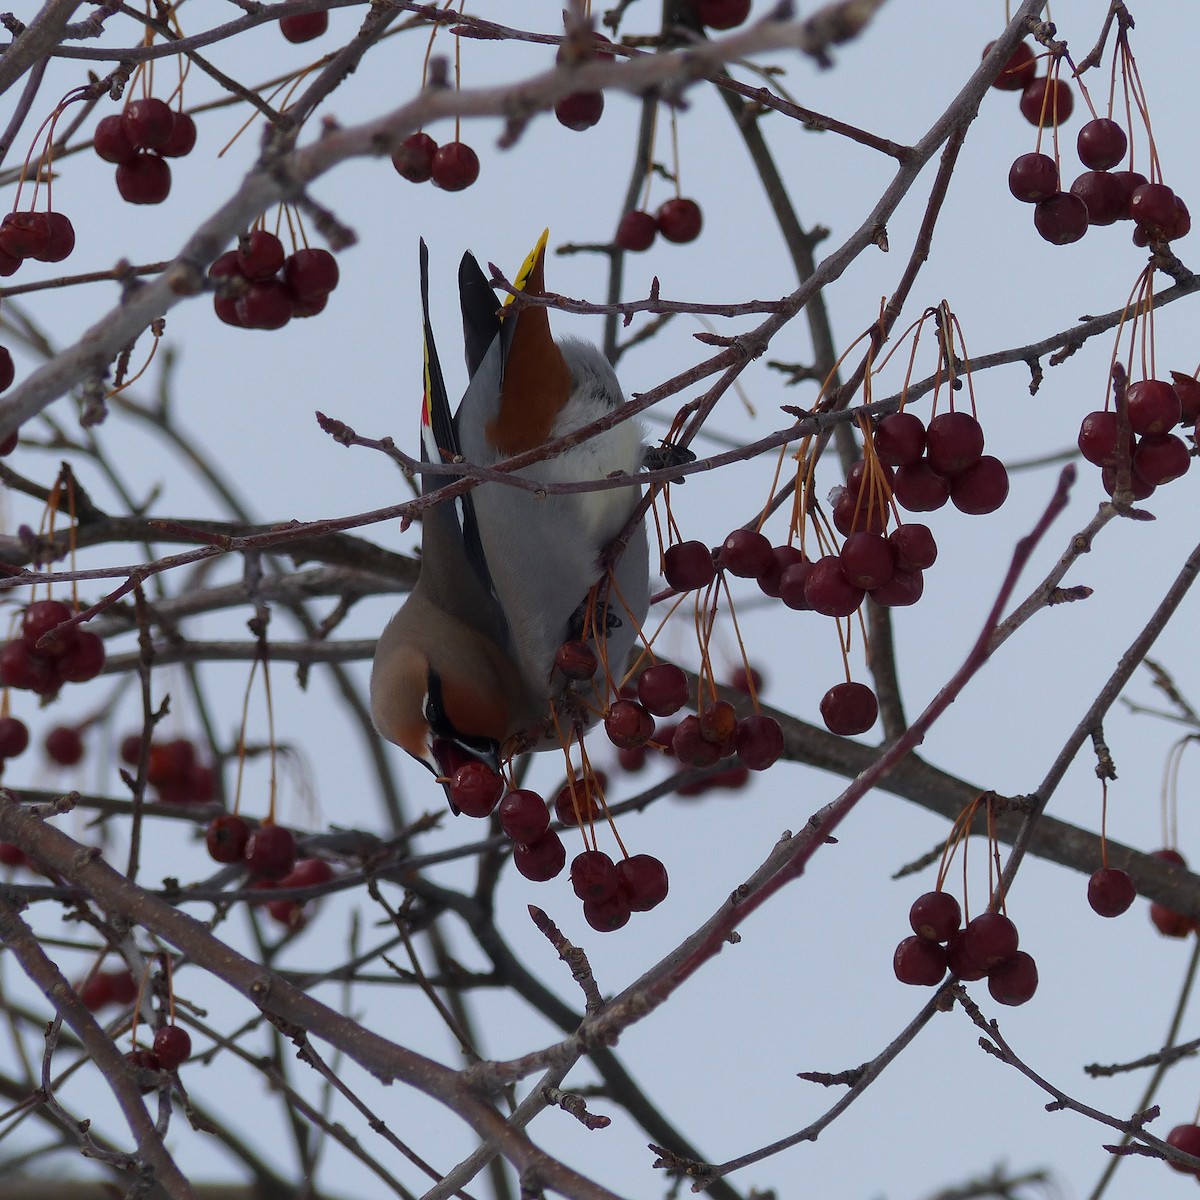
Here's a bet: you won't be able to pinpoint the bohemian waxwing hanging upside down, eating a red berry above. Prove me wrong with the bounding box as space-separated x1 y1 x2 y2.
371 230 649 801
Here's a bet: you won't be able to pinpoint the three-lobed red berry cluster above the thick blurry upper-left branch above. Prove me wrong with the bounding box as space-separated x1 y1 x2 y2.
91 96 196 204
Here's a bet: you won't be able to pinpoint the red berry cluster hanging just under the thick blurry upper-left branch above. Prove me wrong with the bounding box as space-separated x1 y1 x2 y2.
209 229 340 329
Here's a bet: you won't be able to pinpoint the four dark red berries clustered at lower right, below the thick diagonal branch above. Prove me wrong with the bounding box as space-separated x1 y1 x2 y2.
892 890 1038 1004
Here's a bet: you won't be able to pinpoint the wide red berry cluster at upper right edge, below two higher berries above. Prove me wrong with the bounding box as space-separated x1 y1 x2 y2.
1008 116 1192 246
